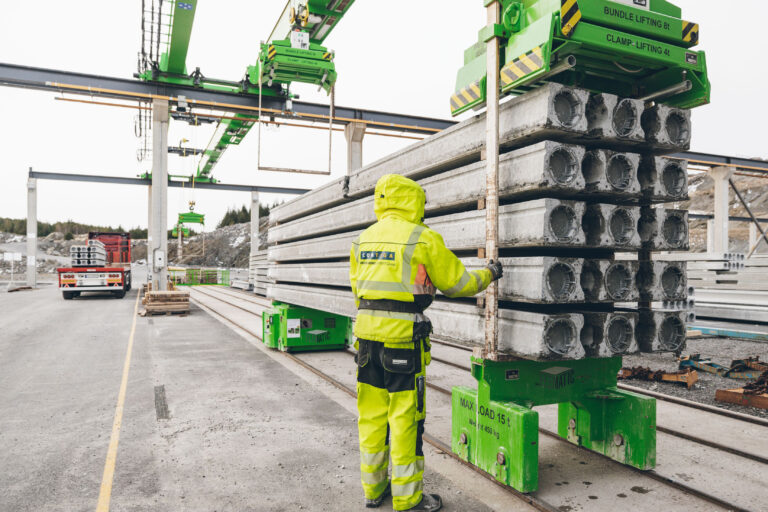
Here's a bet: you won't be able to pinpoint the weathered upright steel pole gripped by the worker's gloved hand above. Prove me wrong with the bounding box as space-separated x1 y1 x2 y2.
483 0 501 360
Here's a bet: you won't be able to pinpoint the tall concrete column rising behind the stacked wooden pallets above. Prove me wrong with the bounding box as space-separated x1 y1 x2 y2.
147 100 168 291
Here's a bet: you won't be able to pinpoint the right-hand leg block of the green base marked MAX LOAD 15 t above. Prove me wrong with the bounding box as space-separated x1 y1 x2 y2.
557 389 656 470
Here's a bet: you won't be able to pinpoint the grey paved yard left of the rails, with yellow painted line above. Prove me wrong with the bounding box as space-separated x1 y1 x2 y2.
0 276 498 511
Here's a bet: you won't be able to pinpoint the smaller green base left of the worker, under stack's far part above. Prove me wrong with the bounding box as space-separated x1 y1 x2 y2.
262 302 352 352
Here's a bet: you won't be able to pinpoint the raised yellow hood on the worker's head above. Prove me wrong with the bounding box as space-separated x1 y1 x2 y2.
373 174 426 224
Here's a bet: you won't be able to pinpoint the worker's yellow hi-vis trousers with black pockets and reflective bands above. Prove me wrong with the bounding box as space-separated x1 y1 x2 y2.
357 339 430 510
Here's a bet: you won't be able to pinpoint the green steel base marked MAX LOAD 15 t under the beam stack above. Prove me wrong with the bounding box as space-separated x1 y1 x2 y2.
451 357 656 492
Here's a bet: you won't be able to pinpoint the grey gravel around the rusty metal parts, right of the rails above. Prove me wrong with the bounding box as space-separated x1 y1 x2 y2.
620 338 768 419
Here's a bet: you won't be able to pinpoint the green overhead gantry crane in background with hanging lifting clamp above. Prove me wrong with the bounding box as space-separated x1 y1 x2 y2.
137 0 354 183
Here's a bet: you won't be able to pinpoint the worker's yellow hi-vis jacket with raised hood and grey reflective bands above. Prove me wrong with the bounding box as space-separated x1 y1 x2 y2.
349 174 492 343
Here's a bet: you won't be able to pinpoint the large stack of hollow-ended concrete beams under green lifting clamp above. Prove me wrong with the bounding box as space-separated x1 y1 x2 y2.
267 84 690 359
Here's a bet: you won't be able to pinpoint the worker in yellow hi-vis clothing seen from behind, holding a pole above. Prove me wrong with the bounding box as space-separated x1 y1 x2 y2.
349 174 502 511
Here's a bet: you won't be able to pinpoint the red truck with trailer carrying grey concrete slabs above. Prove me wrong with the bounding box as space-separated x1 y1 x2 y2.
56 231 131 299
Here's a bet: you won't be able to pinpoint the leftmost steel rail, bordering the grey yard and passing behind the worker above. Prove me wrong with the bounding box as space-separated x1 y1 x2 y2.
186 290 560 512
